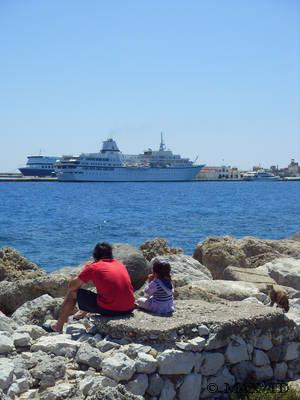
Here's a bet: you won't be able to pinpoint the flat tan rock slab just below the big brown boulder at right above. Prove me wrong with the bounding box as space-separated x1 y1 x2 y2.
223 267 276 284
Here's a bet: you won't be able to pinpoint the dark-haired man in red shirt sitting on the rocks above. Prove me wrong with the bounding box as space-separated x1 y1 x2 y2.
43 243 134 332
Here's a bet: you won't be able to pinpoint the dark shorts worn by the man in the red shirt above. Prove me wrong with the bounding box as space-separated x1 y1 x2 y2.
77 289 133 317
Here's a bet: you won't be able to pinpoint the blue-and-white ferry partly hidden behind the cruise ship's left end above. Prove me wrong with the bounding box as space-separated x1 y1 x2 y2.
19 156 60 177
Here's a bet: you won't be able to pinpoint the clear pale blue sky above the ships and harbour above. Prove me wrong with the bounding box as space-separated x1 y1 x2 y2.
0 0 300 172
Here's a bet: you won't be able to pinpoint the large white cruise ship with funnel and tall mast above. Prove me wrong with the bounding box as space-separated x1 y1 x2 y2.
54 135 204 182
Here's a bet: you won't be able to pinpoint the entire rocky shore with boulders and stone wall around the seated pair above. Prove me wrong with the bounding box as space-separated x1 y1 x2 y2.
0 235 300 400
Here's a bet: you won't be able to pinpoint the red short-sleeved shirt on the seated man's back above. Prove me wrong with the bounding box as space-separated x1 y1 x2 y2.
78 259 134 311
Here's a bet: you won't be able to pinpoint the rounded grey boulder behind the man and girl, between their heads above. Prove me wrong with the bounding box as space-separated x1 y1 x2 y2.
113 243 151 290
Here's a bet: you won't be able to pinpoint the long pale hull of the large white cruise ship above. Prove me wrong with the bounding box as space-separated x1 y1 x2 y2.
56 165 204 182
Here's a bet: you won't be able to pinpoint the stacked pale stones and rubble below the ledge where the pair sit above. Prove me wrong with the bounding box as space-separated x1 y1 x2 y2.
0 315 300 400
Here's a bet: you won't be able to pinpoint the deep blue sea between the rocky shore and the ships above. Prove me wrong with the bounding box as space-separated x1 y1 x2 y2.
0 182 300 271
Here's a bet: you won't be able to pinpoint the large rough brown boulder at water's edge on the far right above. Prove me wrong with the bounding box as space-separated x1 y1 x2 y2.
193 236 300 279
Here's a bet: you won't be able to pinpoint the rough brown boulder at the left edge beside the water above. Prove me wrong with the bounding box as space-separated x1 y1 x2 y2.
0 247 46 281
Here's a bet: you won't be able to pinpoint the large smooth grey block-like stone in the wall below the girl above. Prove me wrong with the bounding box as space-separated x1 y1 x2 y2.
157 350 195 375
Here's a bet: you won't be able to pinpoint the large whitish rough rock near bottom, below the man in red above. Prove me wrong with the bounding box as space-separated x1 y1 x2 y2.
102 353 135 382
